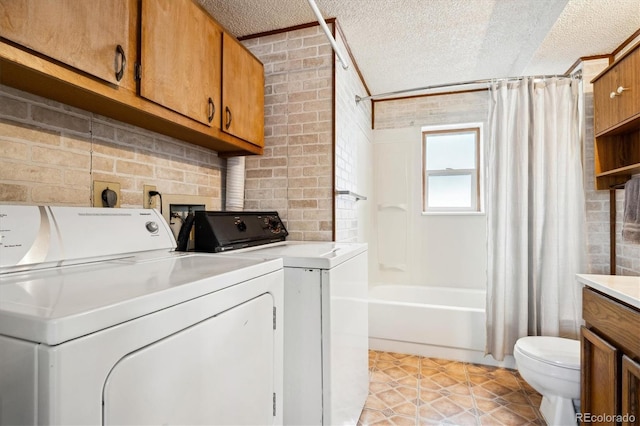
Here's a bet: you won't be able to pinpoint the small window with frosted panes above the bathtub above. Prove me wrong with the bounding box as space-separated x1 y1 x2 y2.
422 124 481 212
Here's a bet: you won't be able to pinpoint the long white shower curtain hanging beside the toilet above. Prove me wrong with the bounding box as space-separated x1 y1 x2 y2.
485 78 586 360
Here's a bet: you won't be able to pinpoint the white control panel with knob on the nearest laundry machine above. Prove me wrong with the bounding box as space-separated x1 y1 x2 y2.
0 205 176 274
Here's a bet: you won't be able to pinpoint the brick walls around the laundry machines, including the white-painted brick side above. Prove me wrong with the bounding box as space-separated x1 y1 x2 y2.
0 20 371 246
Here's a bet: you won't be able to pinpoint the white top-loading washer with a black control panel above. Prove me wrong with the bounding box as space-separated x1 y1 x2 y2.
195 212 369 425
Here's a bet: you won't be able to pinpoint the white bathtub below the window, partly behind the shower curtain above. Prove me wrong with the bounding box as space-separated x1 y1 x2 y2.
369 284 511 367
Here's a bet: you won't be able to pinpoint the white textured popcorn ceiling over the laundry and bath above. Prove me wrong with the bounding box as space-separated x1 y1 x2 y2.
199 0 640 95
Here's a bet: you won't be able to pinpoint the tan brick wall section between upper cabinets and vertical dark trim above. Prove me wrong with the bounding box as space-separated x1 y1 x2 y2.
243 26 334 241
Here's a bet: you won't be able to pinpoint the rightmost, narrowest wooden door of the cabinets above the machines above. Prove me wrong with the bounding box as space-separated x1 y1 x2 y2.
222 33 264 146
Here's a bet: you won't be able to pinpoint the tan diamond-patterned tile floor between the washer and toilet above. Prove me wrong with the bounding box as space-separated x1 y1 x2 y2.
358 351 545 426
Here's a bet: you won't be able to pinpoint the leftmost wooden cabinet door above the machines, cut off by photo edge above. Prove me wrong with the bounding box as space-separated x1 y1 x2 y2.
0 0 137 90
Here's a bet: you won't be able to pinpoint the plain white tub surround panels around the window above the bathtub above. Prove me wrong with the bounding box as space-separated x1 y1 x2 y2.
370 128 487 290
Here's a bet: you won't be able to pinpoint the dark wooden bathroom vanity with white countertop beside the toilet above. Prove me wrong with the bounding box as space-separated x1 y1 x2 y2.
577 275 640 425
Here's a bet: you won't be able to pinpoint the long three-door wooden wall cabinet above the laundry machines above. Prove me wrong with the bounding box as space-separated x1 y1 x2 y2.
0 0 264 157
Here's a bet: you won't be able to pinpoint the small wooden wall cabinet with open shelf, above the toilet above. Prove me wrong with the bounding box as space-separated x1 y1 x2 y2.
592 45 640 189
